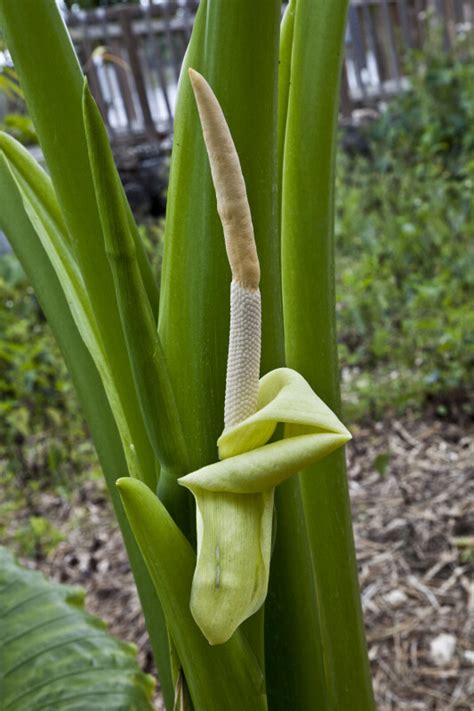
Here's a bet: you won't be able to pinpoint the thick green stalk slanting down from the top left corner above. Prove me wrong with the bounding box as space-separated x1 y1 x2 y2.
0 0 157 486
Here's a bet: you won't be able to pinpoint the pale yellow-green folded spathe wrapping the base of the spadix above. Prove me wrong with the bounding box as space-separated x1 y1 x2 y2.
179 368 351 644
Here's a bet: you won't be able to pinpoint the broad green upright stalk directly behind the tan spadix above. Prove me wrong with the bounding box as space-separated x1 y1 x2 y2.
159 0 283 672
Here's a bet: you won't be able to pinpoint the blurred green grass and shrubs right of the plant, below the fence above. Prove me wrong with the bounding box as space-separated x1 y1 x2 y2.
337 33 474 415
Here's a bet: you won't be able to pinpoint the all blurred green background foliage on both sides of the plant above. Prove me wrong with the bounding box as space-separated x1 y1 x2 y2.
0 34 474 555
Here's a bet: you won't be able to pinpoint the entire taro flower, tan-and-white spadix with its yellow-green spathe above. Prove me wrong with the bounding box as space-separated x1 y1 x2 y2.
179 70 351 644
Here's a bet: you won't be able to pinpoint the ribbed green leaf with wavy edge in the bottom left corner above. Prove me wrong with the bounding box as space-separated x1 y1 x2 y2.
0 547 154 711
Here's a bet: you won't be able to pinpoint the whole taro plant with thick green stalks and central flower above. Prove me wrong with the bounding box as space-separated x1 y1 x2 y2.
0 0 373 711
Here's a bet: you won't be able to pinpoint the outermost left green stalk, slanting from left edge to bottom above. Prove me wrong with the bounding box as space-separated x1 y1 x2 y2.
0 156 173 708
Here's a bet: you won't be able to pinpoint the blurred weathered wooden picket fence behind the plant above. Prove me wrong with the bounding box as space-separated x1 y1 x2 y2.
65 0 474 143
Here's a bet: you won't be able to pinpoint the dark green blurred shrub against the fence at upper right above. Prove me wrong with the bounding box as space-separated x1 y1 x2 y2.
368 31 474 178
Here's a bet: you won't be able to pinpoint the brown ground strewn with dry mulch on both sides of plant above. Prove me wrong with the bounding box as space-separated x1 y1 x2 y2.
20 419 474 711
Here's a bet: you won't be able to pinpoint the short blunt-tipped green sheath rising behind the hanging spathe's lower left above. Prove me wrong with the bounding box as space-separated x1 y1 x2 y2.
117 478 266 711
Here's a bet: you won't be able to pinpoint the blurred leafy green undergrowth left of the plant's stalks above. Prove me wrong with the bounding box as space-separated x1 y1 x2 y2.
0 254 95 485
